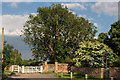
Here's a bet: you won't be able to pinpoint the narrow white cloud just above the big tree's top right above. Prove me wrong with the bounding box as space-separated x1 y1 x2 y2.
61 3 86 10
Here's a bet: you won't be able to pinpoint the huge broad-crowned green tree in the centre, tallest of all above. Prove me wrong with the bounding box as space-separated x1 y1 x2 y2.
23 4 97 62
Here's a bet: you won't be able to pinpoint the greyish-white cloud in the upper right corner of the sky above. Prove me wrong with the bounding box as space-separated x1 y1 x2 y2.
91 2 118 16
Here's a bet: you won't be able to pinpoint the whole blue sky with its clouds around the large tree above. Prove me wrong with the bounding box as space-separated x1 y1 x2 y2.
0 0 118 59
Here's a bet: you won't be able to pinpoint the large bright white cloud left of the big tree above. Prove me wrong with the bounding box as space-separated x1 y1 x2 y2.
0 15 28 36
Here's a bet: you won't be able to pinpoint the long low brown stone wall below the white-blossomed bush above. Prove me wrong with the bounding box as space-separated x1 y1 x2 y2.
71 67 120 80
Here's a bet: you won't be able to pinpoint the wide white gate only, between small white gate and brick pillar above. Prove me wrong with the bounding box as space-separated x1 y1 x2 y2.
22 66 43 73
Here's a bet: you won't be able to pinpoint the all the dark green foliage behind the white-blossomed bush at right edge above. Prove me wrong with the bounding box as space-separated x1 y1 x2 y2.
98 20 120 67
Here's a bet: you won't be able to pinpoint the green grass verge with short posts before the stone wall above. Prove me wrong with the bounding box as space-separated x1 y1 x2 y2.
54 73 101 80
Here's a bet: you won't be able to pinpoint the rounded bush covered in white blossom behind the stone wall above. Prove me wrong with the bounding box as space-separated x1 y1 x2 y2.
73 41 116 67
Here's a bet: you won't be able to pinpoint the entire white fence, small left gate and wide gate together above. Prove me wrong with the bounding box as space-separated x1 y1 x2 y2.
12 65 43 73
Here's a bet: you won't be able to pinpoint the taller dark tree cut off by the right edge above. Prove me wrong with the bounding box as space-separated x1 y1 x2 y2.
108 20 120 56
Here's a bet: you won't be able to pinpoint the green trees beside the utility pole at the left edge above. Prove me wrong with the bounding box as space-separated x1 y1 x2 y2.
3 41 22 68
